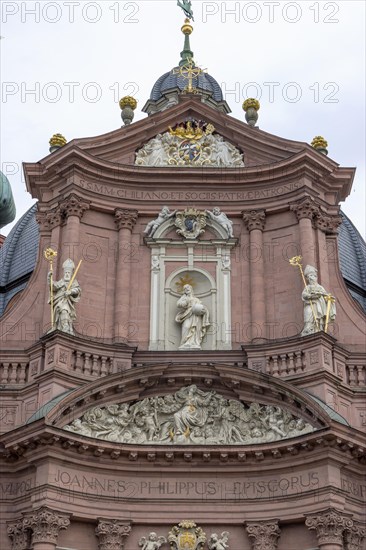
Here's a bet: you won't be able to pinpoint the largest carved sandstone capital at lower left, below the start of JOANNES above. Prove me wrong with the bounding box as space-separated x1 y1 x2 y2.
23 507 70 544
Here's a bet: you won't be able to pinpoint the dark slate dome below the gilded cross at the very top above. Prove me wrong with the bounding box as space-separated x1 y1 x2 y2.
150 67 223 101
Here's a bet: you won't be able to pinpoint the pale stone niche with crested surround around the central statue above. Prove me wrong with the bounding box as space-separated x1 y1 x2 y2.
144 206 237 352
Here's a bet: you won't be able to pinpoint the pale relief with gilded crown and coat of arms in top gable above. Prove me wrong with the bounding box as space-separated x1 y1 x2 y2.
135 119 244 168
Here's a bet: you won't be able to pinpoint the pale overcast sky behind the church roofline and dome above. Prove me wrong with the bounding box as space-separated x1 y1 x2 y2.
0 0 365 235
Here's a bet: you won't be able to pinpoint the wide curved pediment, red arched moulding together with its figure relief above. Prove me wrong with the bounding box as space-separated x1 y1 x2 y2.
40 363 332 445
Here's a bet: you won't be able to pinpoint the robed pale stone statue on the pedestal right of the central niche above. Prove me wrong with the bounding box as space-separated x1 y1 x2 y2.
301 265 336 336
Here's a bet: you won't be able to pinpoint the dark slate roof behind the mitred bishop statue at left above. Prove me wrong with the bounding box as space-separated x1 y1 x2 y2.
0 204 39 315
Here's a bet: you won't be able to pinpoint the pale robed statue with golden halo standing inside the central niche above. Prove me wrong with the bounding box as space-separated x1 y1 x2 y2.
175 285 210 350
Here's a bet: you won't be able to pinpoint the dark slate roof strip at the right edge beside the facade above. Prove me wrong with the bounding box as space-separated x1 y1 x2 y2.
338 212 366 312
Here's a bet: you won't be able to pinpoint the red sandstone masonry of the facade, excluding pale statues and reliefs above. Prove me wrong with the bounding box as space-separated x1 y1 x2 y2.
0 95 366 550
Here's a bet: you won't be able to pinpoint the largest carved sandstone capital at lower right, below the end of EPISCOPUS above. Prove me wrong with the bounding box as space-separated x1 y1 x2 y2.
305 508 353 548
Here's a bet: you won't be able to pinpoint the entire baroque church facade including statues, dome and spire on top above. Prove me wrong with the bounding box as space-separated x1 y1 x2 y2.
0 12 366 550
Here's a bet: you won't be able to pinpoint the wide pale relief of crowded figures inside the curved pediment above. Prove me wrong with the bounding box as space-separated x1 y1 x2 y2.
63 385 316 446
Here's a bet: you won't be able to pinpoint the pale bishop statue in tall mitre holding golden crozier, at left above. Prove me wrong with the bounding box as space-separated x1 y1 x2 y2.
48 258 81 334
